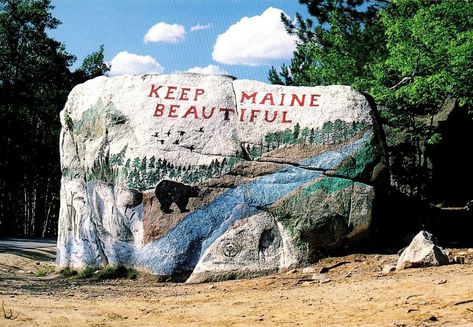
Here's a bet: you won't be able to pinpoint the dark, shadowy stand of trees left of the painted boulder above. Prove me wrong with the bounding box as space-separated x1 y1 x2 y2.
0 0 108 236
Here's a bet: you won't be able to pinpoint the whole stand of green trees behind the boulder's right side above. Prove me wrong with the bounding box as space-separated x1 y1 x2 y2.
269 0 473 204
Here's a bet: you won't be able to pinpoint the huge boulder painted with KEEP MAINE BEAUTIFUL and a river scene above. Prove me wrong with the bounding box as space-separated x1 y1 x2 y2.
57 74 386 282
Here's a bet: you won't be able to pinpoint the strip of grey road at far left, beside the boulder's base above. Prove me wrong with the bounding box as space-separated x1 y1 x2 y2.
0 238 56 260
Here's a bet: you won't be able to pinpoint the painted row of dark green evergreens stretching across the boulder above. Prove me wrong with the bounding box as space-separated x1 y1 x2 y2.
106 120 367 191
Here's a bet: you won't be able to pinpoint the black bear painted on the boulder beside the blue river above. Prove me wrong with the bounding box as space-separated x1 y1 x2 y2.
155 180 199 213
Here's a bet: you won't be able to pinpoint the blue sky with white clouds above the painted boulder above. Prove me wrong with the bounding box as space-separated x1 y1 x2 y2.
50 0 306 82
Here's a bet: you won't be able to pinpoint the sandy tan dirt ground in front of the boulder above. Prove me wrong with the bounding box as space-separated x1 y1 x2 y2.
0 249 473 326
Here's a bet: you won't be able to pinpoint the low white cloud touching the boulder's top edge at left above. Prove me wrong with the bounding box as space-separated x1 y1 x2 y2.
109 51 164 76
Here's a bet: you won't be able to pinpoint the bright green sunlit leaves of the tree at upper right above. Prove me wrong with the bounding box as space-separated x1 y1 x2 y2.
371 0 473 113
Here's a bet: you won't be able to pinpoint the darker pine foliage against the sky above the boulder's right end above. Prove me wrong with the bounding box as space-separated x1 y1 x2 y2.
268 0 385 89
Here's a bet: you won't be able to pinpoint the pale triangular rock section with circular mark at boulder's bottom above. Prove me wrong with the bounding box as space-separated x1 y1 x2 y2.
187 212 300 283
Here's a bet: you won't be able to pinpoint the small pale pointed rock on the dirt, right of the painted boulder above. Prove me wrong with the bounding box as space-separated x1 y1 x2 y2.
396 231 449 270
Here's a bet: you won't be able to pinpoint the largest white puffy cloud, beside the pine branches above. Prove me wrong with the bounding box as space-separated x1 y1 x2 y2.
212 7 297 66
